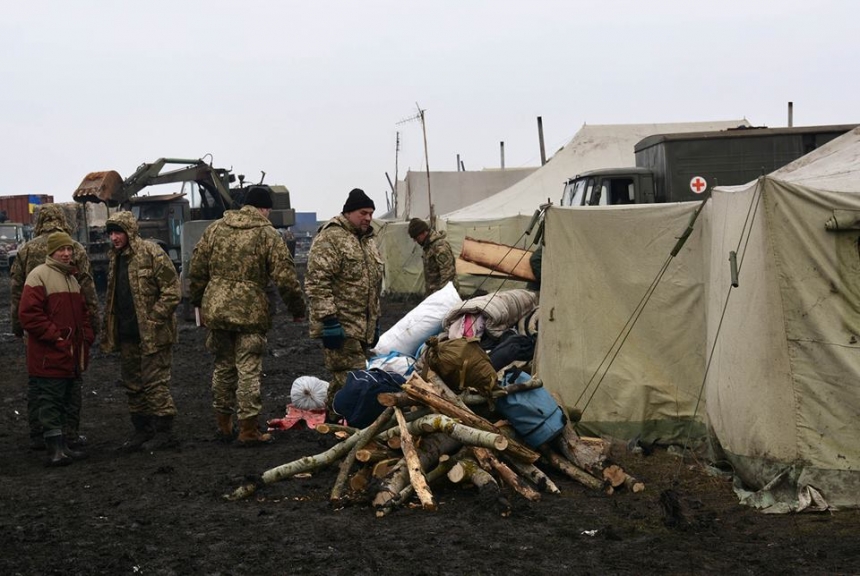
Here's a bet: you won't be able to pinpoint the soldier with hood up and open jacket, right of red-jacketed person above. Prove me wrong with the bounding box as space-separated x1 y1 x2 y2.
102 211 180 451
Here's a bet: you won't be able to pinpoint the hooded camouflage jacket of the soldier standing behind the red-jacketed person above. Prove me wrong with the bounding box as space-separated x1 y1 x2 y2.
9 204 100 336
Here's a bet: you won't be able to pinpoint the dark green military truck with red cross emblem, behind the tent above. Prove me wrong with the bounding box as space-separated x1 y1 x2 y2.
561 124 857 206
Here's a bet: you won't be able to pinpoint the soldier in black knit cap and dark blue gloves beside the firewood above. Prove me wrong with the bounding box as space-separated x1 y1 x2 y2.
305 188 383 418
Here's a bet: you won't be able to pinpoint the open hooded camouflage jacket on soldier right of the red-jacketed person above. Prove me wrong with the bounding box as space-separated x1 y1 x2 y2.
101 212 180 354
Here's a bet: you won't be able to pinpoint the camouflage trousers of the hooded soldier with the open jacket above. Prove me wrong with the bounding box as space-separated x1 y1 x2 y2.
119 342 176 416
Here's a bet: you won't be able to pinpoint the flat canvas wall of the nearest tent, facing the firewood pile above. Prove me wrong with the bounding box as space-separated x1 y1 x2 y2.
537 202 706 444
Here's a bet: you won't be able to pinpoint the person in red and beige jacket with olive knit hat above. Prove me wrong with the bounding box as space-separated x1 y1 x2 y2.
18 232 94 466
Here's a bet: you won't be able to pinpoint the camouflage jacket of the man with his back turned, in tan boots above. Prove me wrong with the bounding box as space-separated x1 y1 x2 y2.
189 206 305 333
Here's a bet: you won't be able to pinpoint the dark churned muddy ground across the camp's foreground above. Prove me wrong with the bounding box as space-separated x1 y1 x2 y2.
0 277 860 575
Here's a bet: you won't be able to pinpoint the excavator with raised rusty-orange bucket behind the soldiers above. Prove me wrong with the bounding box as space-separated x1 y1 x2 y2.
72 158 295 296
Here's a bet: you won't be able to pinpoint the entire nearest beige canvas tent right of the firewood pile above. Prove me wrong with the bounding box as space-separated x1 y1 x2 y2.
537 129 860 511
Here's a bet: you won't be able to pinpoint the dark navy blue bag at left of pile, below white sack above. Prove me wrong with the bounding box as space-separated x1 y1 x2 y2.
332 368 406 428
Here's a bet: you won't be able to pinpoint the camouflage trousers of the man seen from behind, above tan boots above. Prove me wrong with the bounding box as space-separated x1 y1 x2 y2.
206 330 266 420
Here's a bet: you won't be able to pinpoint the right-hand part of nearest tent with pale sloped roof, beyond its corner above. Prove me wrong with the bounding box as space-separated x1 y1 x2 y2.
706 129 860 507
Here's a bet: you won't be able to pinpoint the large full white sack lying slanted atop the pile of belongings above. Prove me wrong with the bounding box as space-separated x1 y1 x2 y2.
373 282 463 356
